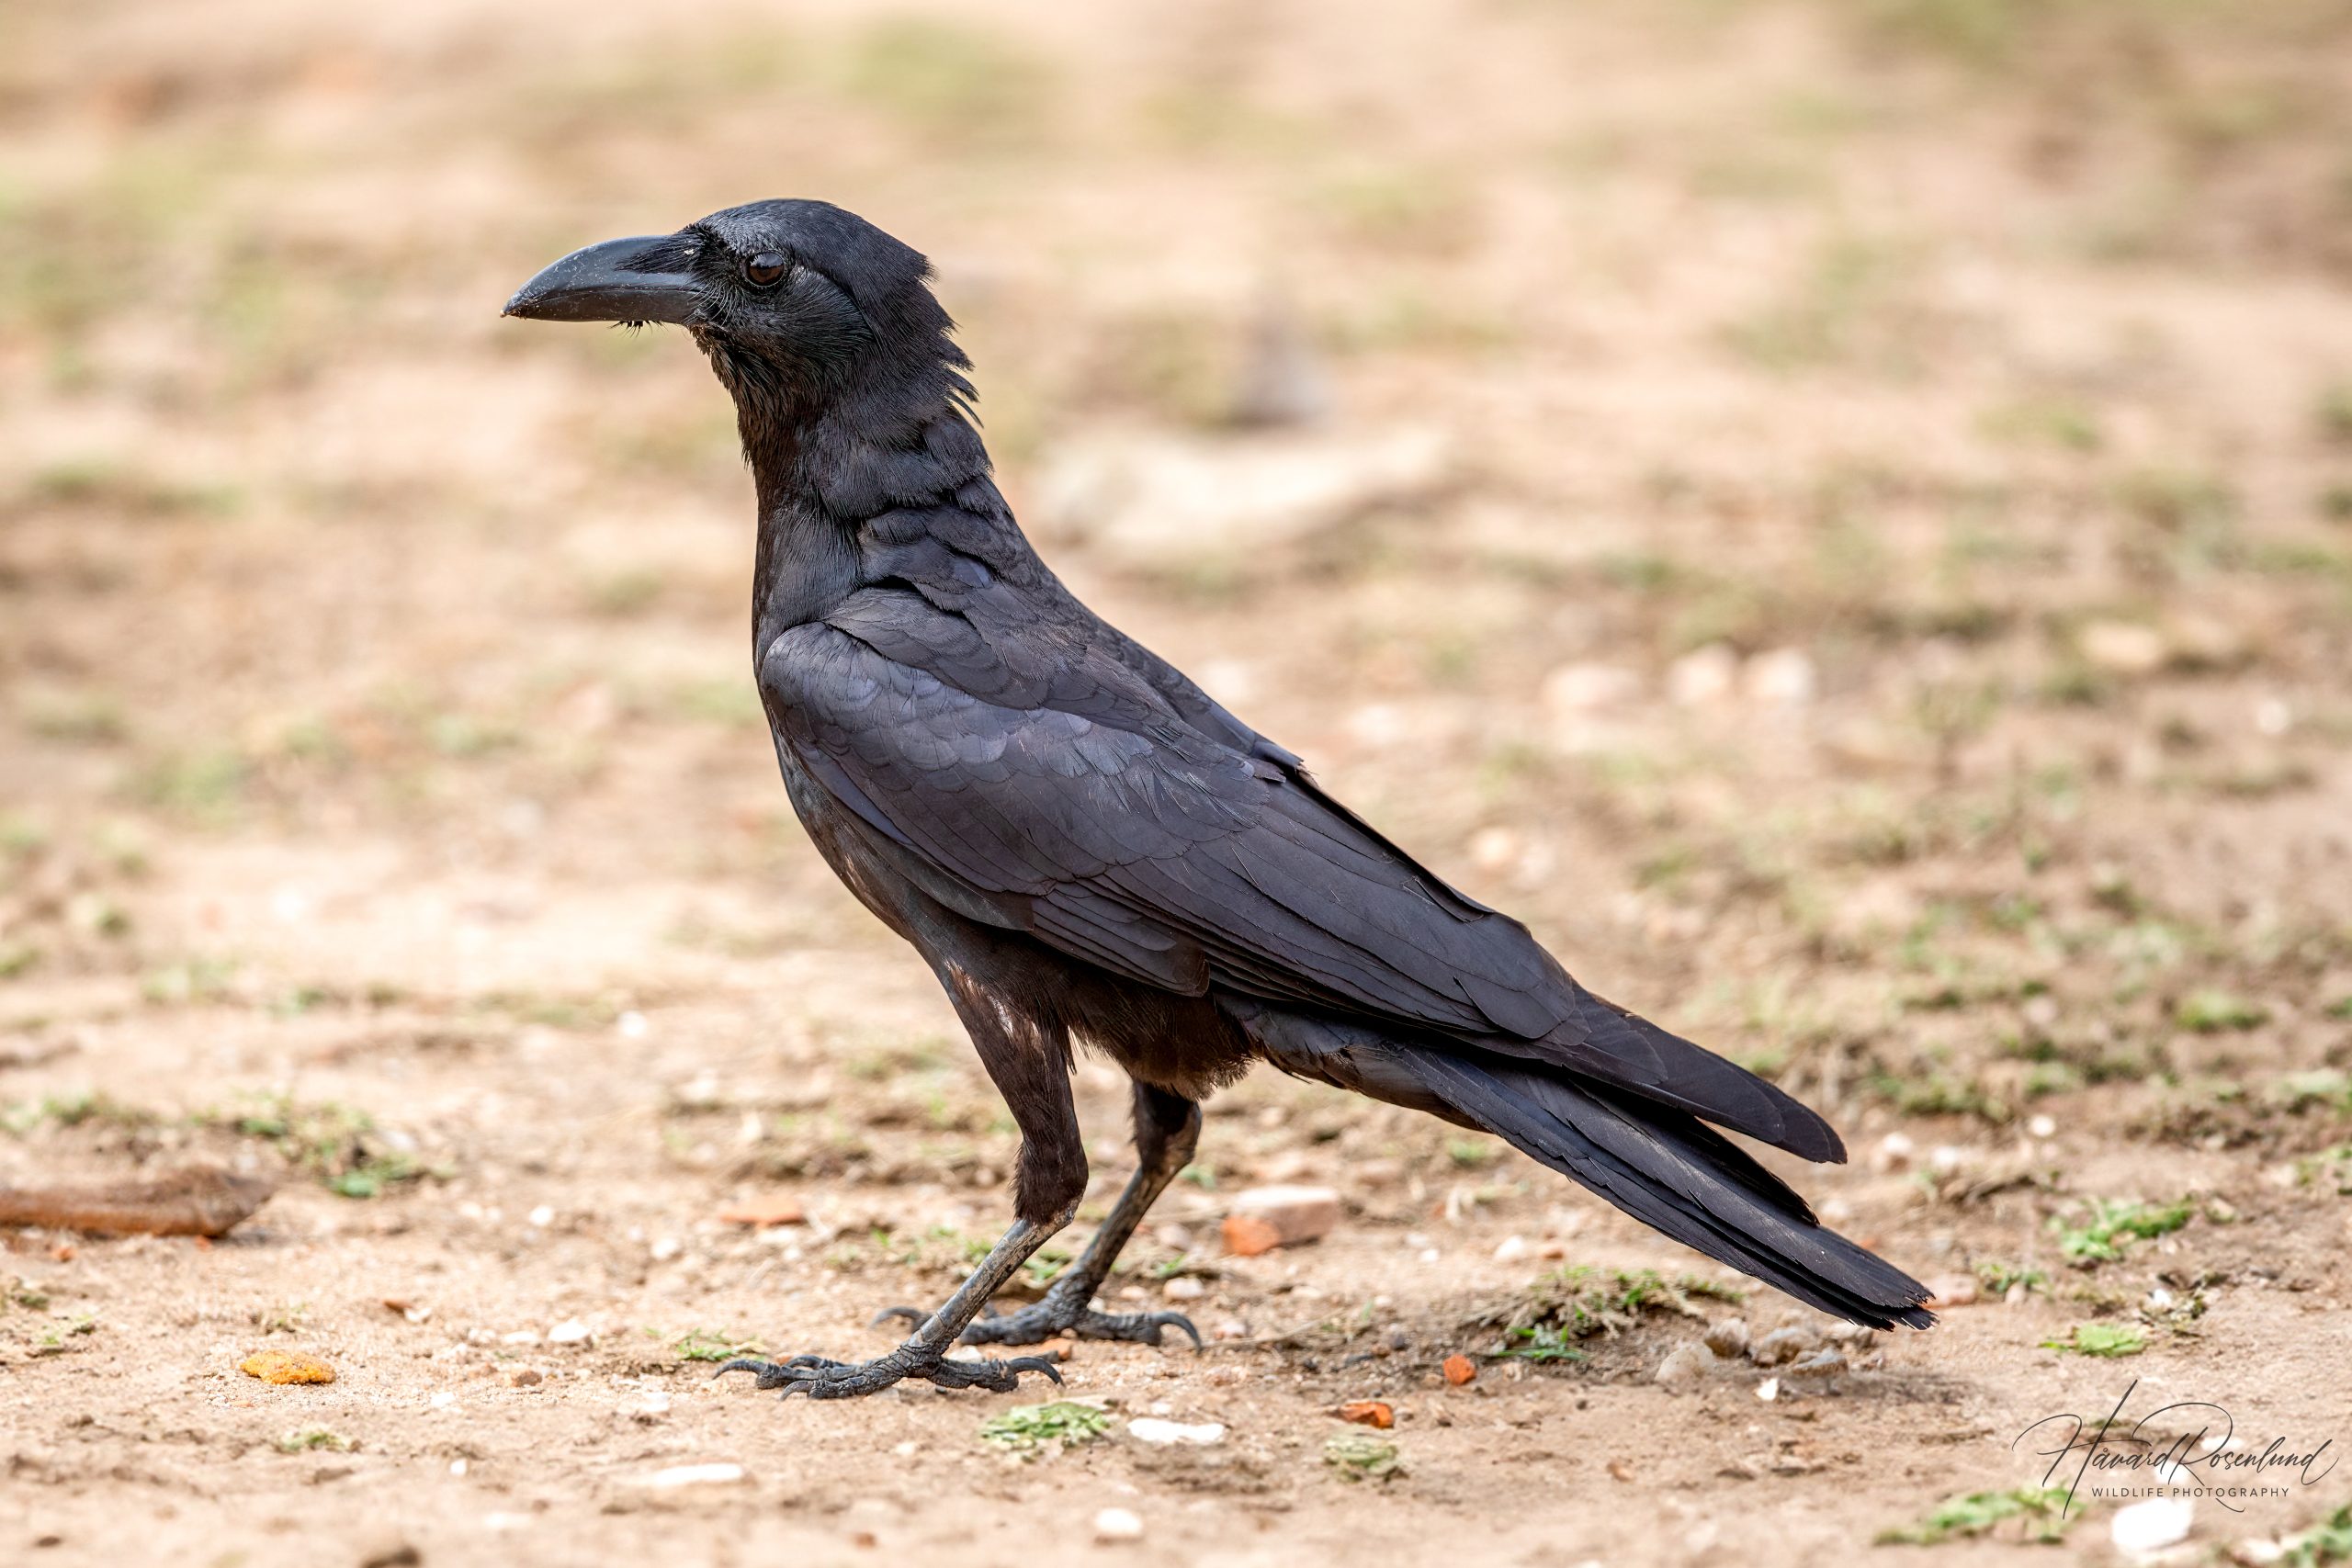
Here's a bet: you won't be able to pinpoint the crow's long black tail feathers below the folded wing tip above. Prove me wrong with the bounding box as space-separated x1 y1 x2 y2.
1226 999 1936 1328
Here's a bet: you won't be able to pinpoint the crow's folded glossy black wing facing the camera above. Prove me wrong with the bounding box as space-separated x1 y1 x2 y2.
760 590 1841 1159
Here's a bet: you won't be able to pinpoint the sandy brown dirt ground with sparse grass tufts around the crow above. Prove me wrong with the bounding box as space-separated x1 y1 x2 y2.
0 0 2352 1568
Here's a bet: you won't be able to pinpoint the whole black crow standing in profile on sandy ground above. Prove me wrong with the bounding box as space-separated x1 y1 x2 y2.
505 200 1933 1399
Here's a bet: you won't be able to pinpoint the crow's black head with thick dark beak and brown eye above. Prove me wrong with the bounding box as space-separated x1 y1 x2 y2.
505 200 969 434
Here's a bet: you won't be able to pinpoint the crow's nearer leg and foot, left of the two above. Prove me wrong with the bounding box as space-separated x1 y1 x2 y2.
719 962 1091 1399
